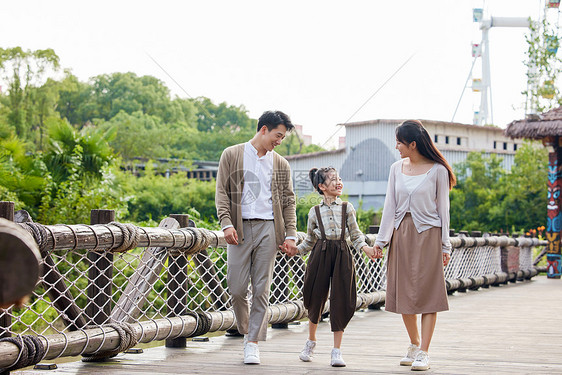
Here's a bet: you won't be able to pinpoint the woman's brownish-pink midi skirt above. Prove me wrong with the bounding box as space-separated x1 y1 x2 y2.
385 213 449 314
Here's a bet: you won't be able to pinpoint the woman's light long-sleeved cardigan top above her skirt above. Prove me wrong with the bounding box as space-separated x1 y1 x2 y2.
376 159 451 253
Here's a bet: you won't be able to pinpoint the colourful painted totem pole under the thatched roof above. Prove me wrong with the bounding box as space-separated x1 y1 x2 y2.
545 137 562 279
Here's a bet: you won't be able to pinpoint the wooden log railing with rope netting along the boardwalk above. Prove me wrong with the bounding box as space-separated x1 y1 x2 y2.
0 202 546 369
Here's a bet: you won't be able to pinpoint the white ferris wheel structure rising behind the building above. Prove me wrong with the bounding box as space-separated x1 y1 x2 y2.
451 0 560 125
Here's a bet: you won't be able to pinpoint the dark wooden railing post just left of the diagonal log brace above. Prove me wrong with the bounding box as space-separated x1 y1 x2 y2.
86 210 115 324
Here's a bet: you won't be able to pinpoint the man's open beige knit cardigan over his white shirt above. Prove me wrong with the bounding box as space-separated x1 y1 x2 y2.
215 143 297 245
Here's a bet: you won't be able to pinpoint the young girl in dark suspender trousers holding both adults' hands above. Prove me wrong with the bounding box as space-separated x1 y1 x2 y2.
290 167 382 367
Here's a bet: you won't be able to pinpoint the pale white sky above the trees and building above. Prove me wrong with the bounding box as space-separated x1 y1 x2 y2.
0 0 558 147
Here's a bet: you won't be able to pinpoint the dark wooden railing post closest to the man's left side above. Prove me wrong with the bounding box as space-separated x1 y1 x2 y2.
166 214 190 348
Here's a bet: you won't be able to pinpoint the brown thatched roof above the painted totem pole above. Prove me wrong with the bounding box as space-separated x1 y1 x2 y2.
505 107 562 139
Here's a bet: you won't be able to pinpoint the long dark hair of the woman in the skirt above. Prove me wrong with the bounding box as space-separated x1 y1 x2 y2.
396 120 457 190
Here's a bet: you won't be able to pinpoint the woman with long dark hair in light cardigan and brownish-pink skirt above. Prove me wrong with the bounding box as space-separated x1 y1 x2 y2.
375 120 456 370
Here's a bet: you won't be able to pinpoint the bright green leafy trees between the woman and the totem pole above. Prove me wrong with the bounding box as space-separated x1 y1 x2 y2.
450 143 548 233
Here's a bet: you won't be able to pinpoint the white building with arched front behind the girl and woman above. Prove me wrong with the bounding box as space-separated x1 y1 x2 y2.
286 120 522 209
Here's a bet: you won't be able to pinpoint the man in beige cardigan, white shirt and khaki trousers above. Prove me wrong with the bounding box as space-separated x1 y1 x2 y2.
215 111 297 364
